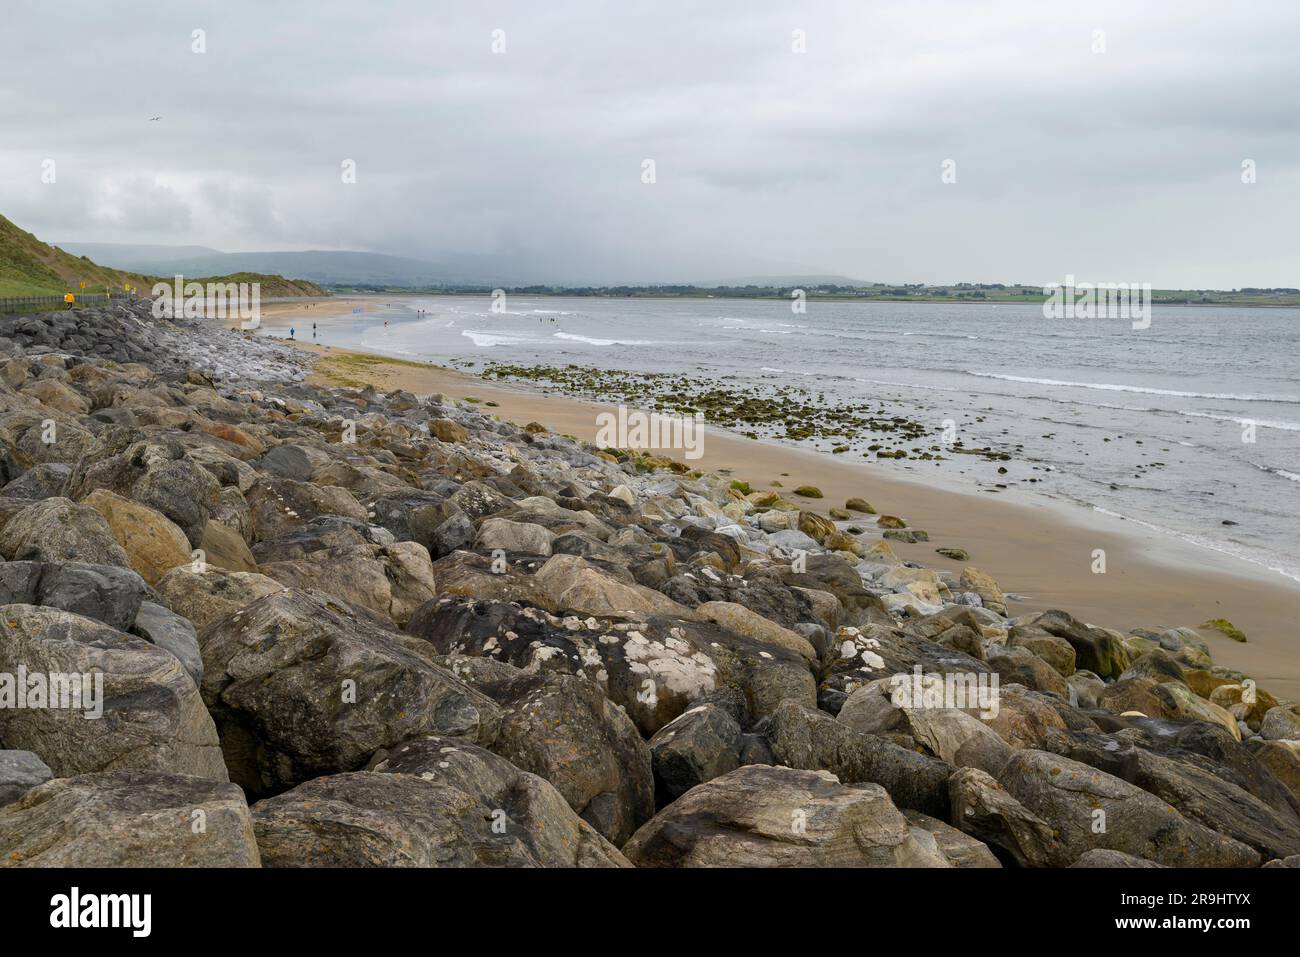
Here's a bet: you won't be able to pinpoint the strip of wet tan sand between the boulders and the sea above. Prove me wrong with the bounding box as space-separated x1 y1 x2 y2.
250 298 1300 700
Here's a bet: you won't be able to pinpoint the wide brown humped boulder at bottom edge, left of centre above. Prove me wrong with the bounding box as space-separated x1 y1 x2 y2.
252 736 629 867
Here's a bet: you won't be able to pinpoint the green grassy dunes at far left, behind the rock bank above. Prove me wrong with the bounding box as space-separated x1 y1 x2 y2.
0 216 329 299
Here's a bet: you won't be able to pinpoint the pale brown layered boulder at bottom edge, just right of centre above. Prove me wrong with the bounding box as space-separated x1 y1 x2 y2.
623 765 949 867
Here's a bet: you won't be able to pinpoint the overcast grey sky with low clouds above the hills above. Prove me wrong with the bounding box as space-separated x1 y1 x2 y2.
0 0 1300 287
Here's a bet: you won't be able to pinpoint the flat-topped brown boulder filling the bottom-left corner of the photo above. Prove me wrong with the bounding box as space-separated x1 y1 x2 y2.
0 771 260 867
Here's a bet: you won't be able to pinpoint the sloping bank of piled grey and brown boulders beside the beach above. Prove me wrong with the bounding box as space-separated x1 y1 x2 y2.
0 303 1300 867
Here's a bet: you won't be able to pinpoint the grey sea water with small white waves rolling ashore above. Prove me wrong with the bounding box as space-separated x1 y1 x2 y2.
289 296 1300 581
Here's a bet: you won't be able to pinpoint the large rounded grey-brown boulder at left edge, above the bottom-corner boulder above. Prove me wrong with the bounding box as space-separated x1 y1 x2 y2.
0 605 228 781
